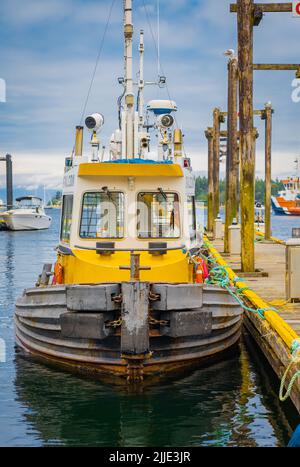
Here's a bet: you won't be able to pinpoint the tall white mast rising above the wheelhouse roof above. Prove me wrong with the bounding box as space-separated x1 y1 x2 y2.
124 0 134 159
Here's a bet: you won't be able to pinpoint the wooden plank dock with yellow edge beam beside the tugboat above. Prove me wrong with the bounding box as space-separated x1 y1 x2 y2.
206 234 300 413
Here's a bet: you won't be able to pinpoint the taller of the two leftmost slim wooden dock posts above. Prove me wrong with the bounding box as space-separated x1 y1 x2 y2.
213 107 221 219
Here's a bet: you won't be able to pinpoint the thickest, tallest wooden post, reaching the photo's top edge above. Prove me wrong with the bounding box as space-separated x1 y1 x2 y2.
237 0 255 272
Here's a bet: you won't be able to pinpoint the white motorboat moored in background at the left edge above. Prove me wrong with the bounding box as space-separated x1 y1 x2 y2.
0 196 52 230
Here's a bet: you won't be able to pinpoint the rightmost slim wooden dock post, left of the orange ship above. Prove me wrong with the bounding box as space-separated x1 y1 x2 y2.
261 102 274 240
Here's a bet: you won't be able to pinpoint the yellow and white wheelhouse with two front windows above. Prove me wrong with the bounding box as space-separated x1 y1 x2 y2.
58 160 199 283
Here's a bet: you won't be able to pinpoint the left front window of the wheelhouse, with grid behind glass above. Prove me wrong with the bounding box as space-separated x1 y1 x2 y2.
80 190 124 238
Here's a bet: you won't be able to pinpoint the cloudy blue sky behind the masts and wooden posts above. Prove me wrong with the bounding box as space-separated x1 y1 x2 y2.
0 0 300 187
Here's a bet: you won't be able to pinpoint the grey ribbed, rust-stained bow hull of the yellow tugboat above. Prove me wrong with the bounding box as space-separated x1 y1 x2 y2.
15 286 242 381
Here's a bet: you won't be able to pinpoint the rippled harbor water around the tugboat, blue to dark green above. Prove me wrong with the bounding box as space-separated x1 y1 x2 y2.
0 209 300 447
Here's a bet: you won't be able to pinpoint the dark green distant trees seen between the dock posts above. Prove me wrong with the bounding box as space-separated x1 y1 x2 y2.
196 177 284 204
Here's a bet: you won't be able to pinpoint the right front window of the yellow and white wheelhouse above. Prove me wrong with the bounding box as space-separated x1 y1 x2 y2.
137 190 180 238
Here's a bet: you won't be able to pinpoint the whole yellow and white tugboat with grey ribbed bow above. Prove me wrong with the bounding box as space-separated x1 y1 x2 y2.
15 0 242 382
